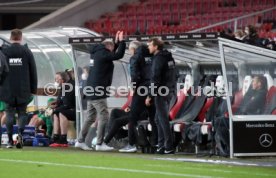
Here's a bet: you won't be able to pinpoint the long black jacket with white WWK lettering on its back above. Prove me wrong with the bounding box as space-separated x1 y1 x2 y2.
0 43 37 105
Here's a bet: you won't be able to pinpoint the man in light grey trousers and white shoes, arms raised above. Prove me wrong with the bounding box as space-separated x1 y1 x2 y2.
75 32 126 151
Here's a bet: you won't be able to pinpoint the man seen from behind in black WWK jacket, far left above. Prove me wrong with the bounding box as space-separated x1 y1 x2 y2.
0 29 37 148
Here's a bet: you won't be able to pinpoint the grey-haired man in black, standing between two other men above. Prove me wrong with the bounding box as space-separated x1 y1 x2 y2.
119 41 157 153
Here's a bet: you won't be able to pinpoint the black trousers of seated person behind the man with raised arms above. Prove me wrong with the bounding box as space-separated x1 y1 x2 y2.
104 109 129 144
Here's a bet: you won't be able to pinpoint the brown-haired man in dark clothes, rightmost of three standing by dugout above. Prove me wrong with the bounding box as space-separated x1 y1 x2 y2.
145 38 177 154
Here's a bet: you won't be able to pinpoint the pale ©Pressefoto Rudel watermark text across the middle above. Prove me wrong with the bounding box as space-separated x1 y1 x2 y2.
44 82 233 97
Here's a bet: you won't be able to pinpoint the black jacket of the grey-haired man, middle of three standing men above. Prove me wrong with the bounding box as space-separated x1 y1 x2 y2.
129 45 152 87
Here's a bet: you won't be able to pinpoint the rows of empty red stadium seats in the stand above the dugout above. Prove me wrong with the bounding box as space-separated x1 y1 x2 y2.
85 0 276 34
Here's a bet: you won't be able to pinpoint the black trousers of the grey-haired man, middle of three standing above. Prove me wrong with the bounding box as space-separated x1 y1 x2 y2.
128 93 158 145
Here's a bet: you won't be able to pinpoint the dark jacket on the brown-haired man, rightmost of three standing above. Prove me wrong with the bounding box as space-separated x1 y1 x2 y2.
151 50 177 95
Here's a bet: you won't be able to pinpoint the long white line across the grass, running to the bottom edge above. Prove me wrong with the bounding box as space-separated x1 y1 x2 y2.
0 159 218 178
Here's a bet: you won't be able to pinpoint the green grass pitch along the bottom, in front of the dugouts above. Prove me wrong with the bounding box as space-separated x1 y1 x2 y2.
0 147 276 178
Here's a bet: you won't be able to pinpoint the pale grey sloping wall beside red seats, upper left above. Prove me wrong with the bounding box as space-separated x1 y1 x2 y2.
25 0 137 29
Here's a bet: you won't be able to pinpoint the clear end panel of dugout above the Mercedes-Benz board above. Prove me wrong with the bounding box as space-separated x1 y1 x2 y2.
223 43 276 115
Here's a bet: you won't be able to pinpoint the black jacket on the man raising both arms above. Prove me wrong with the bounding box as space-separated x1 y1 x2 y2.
87 41 126 100
